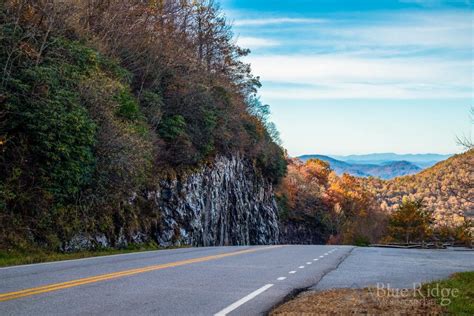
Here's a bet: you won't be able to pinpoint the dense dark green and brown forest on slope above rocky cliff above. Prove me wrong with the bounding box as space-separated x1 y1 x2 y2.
0 0 286 249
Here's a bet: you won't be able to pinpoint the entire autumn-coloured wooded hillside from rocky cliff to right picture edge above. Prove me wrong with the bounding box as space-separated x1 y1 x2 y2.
278 149 474 245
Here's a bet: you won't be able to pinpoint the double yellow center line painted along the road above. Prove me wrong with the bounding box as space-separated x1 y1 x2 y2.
0 246 281 302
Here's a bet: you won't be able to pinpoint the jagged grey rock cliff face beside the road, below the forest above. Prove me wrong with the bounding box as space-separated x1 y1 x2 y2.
63 156 279 251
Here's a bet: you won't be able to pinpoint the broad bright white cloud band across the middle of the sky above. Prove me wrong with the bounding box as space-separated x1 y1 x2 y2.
245 54 471 84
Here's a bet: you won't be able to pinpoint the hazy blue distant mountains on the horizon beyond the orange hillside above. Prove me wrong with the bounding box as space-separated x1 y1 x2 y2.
298 155 423 179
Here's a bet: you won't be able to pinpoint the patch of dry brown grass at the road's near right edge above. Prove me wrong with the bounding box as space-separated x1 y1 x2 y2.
270 289 445 316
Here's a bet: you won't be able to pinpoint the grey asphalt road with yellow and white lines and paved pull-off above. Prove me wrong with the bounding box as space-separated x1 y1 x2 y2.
0 246 474 315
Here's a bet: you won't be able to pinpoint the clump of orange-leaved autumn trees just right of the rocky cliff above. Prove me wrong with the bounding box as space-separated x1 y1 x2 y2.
278 159 386 245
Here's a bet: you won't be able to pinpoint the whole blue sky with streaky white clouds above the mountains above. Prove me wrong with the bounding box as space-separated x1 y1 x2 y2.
220 0 474 156
